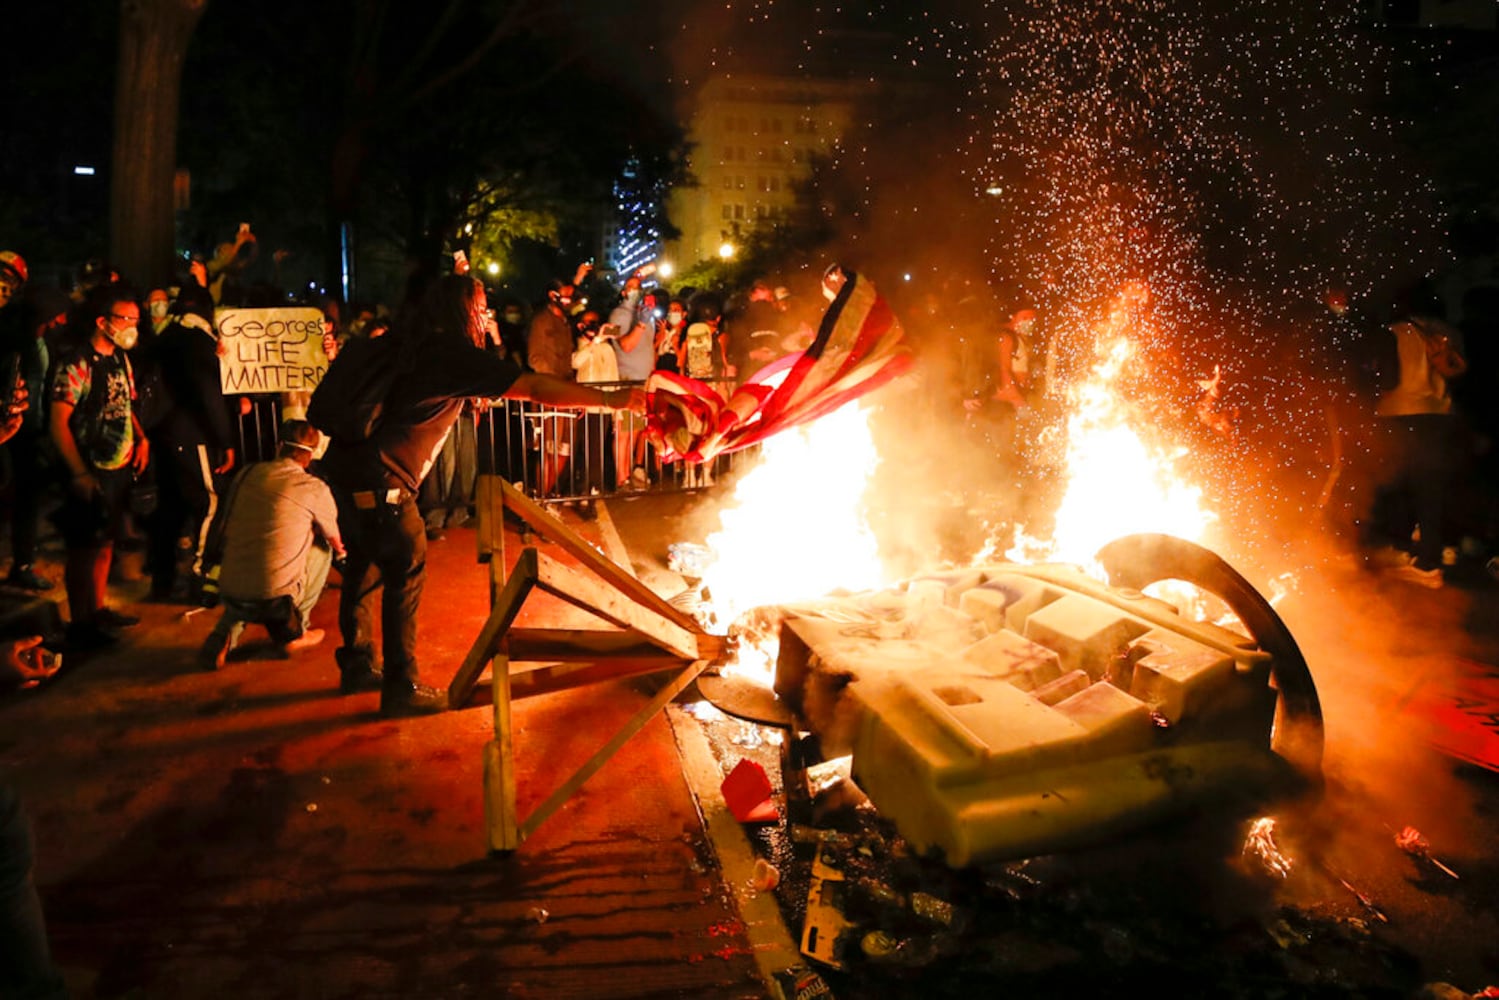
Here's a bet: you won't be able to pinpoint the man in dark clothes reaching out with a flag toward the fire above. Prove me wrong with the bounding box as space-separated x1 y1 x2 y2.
309 274 646 715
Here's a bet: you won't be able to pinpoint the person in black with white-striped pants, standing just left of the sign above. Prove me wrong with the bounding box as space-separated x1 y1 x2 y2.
147 286 235 600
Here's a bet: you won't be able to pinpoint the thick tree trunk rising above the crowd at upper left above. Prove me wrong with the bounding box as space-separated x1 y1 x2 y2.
109 0 208 292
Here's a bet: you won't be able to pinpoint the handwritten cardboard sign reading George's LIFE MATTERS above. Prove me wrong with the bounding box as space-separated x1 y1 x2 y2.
213 307 328 396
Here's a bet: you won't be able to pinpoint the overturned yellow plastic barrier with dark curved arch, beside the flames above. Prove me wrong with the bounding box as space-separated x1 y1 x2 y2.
773 535 1322 867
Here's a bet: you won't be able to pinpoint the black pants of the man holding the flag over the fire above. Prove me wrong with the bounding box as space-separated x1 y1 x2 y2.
333 489 427 694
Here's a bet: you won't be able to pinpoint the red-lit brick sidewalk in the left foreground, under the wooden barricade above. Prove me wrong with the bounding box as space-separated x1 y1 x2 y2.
0 512 764 999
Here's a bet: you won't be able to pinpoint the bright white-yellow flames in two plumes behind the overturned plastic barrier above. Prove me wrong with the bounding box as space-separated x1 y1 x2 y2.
703 284 1214 679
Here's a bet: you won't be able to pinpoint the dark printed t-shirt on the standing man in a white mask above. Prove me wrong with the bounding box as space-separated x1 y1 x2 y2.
49 348 135 469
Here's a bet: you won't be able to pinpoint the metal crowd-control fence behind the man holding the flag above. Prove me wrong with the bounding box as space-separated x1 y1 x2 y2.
238 379 757 502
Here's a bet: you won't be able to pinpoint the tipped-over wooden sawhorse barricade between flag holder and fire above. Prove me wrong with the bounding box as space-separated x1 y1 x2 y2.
461 475 727 853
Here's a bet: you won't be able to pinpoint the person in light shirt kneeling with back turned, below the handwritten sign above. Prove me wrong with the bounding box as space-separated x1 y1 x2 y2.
198 420 343 670
